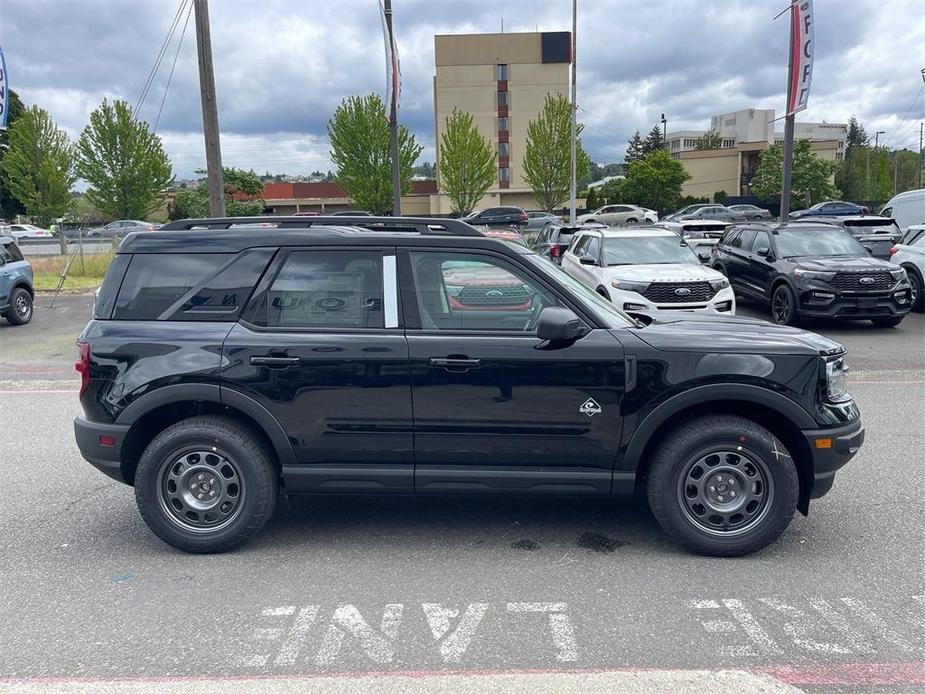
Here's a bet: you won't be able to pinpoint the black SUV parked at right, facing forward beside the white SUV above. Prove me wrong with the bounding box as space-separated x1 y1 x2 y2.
710 222 912 327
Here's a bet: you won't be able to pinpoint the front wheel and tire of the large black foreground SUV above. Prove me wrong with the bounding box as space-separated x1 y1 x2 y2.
646 415 800 557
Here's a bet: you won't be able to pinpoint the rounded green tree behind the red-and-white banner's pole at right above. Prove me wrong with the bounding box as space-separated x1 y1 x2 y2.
752 140 841 206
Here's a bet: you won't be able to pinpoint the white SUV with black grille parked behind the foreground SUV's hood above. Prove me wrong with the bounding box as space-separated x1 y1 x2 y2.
562 228 735 314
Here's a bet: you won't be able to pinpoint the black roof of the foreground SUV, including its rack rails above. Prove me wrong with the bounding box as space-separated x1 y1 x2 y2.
118 216 530 253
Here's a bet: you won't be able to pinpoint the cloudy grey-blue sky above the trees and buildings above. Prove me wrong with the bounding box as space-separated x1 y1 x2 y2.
0 0 925 178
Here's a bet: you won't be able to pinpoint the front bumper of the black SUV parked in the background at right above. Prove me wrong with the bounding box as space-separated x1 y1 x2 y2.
800 283 912 320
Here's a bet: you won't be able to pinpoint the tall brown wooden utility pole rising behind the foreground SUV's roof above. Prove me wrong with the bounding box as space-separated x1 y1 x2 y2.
193 0 225 217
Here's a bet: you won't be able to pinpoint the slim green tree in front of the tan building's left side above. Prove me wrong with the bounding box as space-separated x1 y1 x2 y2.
440 108 498 216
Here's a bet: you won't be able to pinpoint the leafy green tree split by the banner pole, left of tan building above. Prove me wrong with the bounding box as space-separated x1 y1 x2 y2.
328 94 423 214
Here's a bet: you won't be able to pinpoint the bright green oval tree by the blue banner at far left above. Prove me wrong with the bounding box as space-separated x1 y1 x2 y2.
0 106 75 225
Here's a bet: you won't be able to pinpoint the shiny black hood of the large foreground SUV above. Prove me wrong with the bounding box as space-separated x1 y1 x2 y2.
637 311 845 355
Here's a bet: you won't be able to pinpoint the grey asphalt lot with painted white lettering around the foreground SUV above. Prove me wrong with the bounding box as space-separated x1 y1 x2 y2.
0 296 925 693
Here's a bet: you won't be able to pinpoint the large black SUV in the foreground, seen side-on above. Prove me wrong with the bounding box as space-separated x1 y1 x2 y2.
75 217 864 556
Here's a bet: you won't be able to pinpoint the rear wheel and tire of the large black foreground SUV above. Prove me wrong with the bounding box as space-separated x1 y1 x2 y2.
135 415 279 554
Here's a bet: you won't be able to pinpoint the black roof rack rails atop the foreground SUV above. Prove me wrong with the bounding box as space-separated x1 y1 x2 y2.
160 215 483 236
